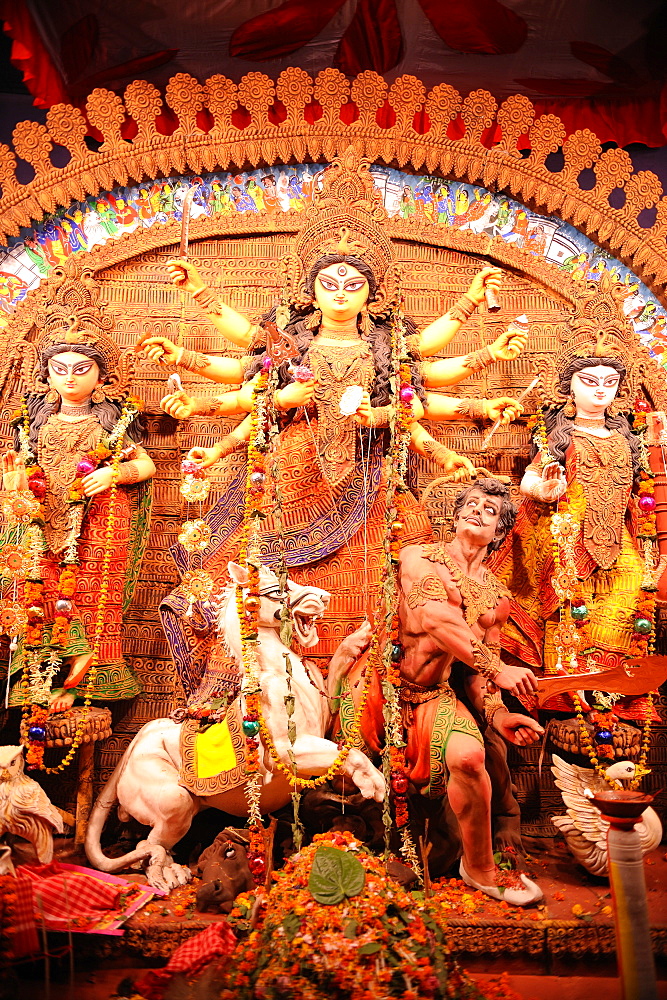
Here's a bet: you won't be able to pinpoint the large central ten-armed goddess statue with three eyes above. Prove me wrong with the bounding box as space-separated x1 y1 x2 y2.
142 156 525 704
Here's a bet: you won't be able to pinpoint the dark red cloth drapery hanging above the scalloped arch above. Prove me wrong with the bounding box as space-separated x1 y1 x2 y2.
0 0 667 146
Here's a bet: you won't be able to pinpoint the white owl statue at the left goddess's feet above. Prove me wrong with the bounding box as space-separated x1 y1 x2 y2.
0 746 63 864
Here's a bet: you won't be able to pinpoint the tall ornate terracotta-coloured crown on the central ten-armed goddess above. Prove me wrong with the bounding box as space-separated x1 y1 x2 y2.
283 147 399 315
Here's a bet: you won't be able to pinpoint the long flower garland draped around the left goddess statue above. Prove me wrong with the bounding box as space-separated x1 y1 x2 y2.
6 396 142 774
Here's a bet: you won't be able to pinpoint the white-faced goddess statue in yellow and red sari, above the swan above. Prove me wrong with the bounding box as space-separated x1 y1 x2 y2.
490 338 656 719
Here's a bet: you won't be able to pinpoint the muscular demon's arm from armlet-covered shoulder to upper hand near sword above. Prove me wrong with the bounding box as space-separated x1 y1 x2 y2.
401 545 537 697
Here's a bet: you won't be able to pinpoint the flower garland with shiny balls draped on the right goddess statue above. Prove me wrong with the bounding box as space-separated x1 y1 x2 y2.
533 400 657 788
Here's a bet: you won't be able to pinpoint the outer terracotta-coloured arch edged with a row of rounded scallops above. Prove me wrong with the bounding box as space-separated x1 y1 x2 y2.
0 67 667 303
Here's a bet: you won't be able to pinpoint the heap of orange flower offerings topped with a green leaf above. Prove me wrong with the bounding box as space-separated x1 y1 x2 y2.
220 833 513 1000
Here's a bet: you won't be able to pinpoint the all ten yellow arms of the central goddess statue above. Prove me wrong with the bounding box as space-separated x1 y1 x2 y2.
142 260 526 478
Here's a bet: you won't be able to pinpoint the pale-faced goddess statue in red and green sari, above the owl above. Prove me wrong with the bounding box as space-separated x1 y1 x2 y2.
0 279 155 712
